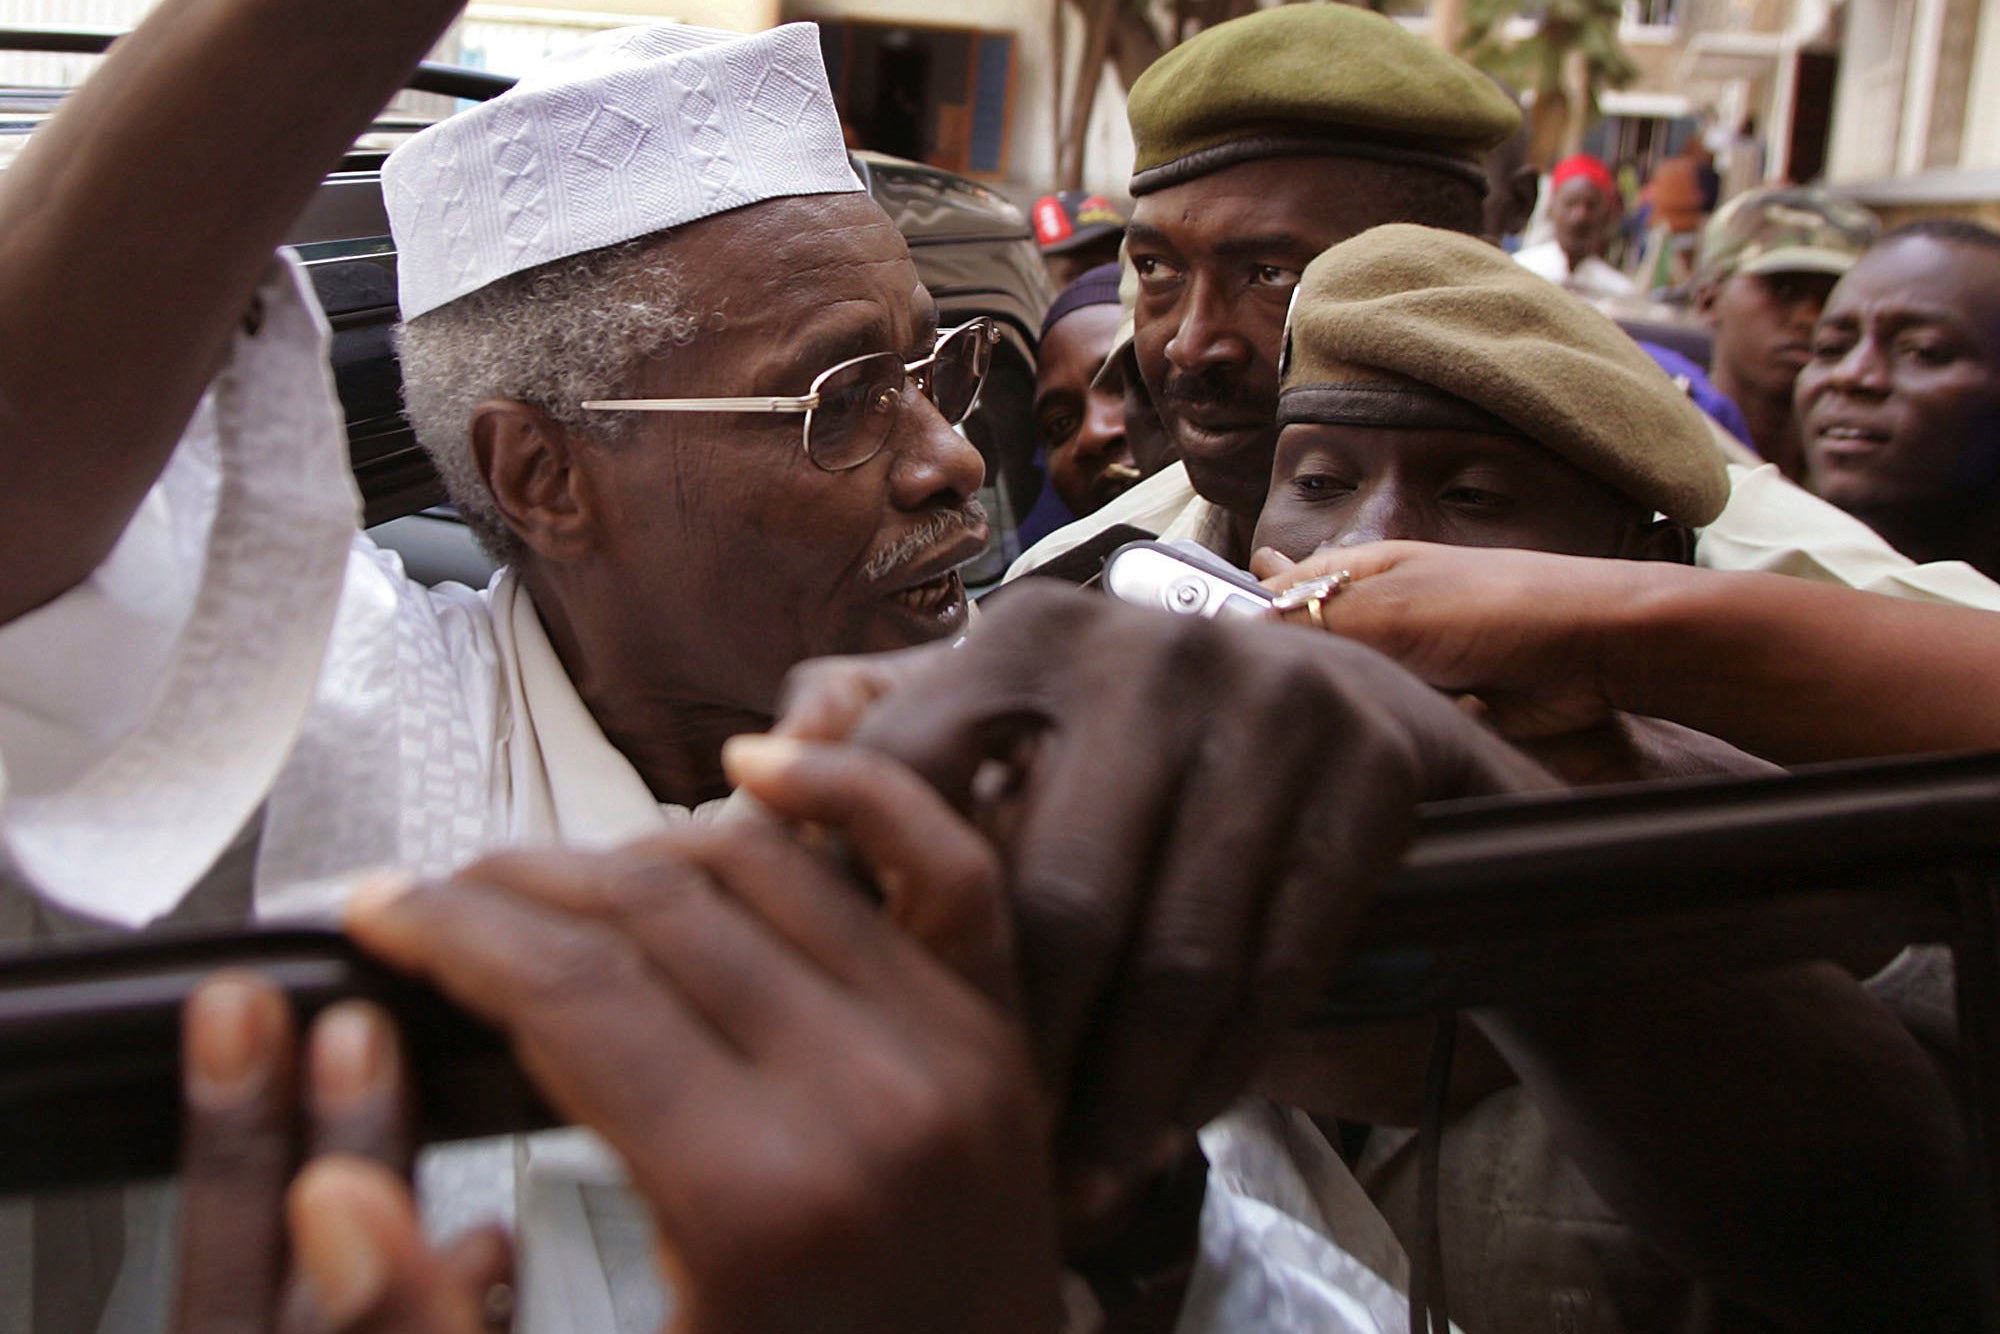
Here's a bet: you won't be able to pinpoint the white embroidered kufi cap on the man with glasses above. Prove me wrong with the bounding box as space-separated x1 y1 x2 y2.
382 24 862 320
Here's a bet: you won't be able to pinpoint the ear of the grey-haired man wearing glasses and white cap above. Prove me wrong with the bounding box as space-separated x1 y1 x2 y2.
472 398 592 560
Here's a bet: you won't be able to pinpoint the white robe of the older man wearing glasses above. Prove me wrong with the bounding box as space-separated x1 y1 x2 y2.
0 262 1406 1334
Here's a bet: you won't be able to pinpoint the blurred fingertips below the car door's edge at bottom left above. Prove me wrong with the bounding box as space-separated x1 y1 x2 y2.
174 974 512 1334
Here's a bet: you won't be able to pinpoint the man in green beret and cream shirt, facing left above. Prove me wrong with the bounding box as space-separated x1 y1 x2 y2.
1012 4 2000 610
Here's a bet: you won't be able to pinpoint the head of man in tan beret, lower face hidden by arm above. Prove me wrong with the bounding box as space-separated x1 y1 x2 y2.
1256 224 1728 560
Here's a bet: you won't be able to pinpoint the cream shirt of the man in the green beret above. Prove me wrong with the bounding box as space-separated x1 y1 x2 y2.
1008 454 2000 612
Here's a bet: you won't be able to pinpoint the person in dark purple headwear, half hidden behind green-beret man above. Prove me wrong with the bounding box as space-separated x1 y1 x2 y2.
1020 260 1140 544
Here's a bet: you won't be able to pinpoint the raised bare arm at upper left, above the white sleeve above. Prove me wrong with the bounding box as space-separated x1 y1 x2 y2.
0 0 460 620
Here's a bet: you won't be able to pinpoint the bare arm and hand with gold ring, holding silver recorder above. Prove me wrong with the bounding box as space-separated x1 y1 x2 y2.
1254 542 2000 764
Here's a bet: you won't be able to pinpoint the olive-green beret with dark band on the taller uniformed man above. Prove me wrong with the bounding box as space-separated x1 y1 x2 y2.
1126 4 1520 194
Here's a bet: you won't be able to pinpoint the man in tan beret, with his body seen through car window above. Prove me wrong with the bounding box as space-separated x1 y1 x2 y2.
1256 226 1968 1334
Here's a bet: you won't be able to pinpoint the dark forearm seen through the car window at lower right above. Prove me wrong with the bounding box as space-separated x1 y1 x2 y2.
1482 964 1980 1330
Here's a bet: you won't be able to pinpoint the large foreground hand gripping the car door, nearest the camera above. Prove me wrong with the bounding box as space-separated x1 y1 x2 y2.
348 740 1060 1334
